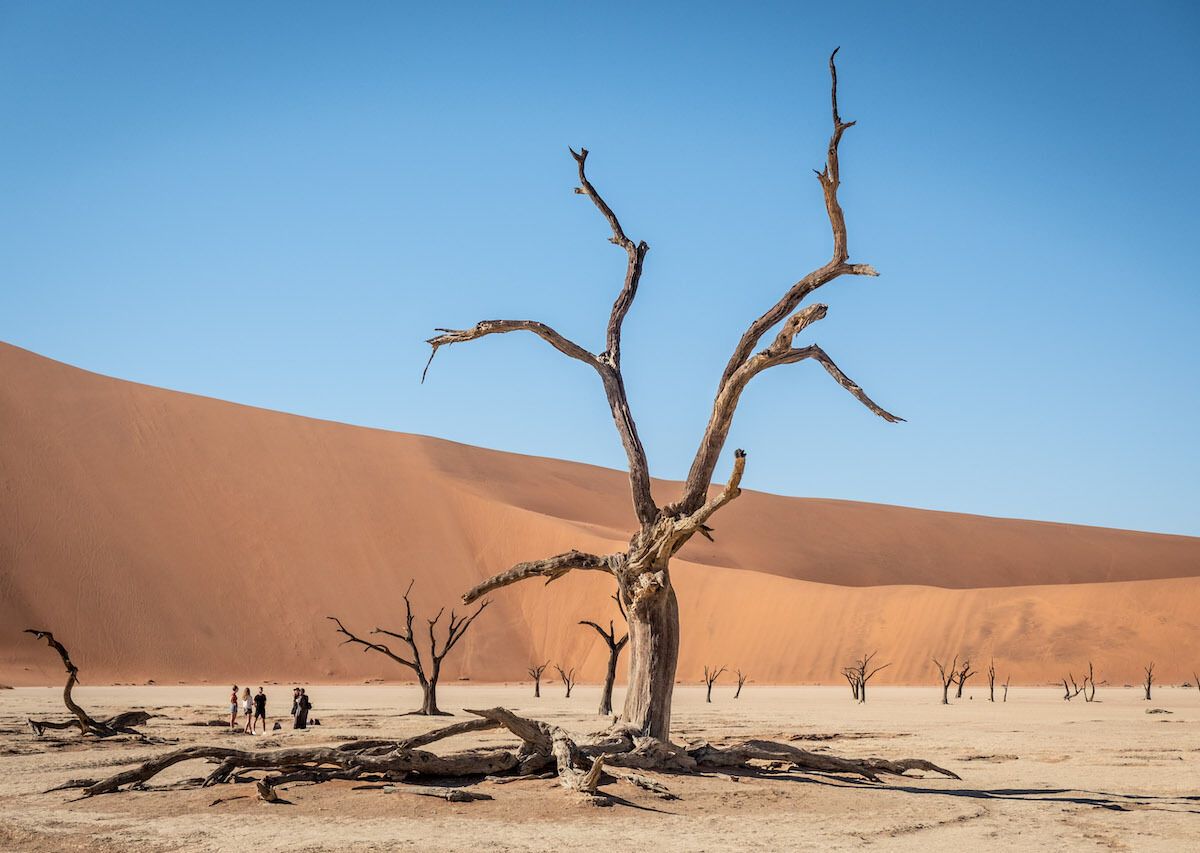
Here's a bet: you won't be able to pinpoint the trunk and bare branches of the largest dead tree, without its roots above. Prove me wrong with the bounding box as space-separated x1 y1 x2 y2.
422 52 902 740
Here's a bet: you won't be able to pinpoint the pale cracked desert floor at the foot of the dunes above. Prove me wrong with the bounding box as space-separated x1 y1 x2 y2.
0 683 1200 852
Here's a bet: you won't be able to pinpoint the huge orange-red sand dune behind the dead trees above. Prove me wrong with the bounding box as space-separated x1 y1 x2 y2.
0 344 1200 684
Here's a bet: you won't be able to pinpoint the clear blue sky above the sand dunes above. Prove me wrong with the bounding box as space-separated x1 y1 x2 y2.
0 0 1200 535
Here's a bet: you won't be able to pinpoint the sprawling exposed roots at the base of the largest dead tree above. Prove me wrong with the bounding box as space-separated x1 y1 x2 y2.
65 708 959 805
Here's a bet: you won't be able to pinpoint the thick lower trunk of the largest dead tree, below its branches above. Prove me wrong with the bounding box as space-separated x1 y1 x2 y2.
623 580 679 740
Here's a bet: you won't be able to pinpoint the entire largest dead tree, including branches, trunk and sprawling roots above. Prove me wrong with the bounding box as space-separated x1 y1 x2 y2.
72 50 959 803
